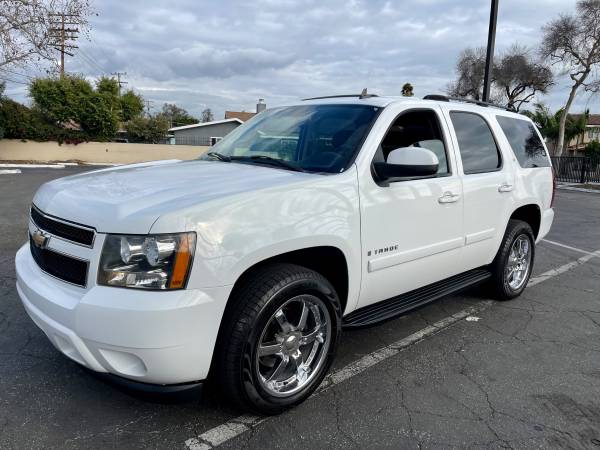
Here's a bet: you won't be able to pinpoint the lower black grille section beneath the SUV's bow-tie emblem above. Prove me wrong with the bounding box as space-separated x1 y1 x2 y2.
29 236 88 287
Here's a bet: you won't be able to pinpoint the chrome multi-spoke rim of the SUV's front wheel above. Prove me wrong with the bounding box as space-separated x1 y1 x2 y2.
254 295 332 397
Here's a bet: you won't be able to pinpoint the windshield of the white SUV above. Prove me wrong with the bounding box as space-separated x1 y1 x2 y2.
203 105 380 173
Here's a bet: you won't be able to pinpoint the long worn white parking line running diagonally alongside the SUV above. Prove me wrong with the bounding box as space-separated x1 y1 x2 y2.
185 246 600 450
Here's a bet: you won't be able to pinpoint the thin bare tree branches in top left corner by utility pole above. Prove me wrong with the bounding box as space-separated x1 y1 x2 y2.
0 0 91 67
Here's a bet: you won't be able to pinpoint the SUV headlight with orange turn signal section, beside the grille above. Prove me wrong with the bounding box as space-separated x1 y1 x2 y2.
98 232 196 289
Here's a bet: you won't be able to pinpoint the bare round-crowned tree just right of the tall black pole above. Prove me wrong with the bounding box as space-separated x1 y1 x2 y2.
493 44 554 111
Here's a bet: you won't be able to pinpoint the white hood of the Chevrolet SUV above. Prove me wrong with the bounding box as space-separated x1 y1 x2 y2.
33 160 320 234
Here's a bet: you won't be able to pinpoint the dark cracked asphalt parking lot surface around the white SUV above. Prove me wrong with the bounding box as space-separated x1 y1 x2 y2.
0 167 600 450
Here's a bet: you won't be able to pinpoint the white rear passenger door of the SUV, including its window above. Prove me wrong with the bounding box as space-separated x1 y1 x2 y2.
442 105 515 269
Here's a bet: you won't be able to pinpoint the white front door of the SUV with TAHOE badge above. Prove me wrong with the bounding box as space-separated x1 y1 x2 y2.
358 108 464 307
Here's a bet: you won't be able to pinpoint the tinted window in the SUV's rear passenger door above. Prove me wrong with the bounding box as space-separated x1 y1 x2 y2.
450 112 502 173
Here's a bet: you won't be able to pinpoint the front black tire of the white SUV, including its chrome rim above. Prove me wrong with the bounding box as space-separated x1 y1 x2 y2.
215 264 342 414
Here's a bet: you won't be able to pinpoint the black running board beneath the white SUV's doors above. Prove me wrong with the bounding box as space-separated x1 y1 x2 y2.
342 269 492 328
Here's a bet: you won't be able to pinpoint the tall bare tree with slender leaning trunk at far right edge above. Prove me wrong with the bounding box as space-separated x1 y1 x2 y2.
541 0 600 156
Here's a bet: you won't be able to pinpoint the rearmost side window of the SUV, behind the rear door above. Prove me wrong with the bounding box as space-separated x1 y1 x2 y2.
496 116 550 169
